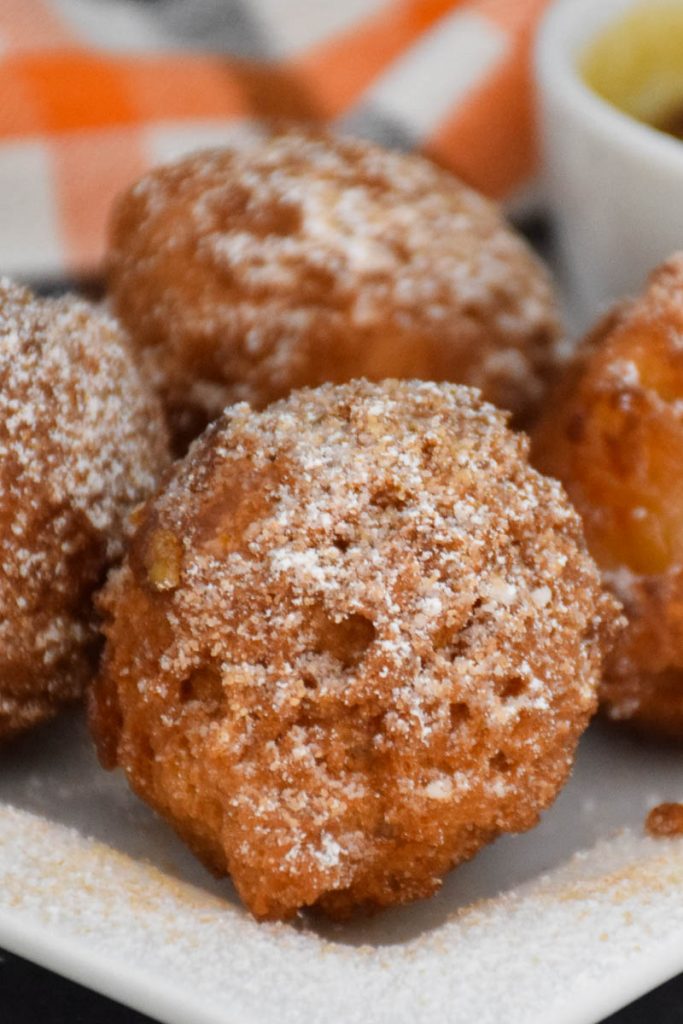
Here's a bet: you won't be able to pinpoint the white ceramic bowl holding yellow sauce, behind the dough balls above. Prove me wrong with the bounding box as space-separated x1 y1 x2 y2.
536 0 683 328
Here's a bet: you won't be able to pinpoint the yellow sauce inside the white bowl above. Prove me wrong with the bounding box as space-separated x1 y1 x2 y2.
581 0 683 138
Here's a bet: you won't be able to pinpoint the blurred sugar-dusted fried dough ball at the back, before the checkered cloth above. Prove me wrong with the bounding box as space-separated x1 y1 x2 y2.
109 130 559 448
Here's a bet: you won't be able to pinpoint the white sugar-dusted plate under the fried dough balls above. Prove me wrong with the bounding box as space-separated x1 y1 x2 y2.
0 716 683 1024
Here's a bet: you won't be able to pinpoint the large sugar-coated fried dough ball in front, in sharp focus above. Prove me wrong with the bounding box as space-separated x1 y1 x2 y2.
91 381 615 918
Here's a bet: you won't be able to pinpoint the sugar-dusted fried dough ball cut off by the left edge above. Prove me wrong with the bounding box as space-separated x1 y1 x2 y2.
0 280 168 739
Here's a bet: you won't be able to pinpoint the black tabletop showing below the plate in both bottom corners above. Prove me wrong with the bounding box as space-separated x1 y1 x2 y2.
0 950 683 1024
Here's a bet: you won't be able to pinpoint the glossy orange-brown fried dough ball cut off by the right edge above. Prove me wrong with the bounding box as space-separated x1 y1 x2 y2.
535 254 683 738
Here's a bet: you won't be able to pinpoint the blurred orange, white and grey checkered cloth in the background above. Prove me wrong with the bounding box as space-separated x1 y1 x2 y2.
0 0 547 279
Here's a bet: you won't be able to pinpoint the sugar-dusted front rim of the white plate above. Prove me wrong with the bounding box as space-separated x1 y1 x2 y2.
0 807 683 1024
